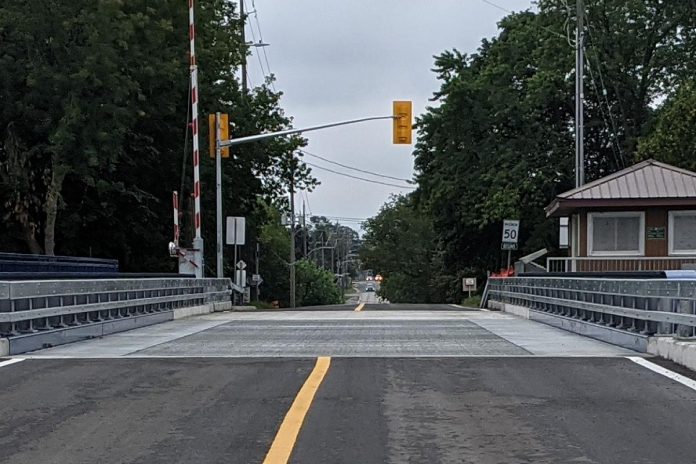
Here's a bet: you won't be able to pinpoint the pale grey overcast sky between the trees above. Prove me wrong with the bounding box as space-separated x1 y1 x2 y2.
245 0 532 229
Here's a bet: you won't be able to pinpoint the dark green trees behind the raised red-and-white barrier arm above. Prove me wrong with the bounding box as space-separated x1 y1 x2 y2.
0 0 314 273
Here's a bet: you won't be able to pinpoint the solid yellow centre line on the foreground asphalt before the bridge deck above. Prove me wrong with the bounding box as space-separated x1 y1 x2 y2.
263 356 331 464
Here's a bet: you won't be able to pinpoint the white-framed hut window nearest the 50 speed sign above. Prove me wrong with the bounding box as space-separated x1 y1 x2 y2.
587 212 645 256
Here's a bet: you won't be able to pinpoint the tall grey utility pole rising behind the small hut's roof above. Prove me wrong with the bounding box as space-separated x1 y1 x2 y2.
575 0 585 187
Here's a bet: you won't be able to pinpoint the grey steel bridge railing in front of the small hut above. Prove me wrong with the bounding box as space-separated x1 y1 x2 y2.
487 277 696 338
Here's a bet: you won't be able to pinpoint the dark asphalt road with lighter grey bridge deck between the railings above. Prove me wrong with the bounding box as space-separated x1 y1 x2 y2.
0 305 696 464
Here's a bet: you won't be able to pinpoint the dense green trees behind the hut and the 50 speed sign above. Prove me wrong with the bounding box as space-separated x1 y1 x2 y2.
363 0 696 302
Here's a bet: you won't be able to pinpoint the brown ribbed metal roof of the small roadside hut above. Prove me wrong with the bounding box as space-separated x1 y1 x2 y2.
546 159 696 216
